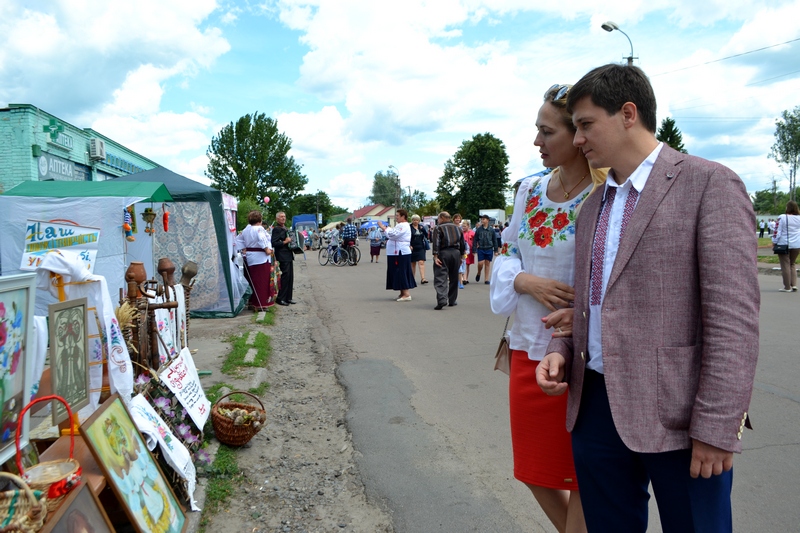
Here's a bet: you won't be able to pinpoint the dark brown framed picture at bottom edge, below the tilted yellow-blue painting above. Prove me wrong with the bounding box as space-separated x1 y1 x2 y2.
40 483 115 533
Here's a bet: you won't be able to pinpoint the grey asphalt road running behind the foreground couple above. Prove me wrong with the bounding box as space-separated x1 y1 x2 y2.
304 246 800 533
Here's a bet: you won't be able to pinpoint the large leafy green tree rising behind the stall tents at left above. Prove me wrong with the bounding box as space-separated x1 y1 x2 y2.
205 112 308 211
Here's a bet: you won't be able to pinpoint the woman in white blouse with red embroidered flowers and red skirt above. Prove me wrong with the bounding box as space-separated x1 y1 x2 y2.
490 85 606 532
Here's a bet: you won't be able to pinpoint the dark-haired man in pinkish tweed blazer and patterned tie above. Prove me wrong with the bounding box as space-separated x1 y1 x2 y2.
537 65 760 532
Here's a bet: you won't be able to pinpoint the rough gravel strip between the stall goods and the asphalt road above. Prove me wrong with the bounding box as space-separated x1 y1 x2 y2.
190 262 393 533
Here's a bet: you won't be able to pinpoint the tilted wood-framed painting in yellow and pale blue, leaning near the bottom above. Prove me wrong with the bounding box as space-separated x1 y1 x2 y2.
80 394 188 533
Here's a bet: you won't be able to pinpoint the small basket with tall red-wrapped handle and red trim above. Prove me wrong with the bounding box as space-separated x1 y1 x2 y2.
16 394 81 511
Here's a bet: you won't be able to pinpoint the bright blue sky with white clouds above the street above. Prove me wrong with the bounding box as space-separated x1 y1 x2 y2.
0 0 800 208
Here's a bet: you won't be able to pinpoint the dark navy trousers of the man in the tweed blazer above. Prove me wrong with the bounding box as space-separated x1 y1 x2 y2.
572 369 733 533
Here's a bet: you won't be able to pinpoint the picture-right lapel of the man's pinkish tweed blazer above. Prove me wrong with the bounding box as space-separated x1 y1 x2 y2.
606 145 683 292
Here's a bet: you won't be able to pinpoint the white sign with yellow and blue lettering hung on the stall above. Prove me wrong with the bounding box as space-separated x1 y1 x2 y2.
19 220 100 273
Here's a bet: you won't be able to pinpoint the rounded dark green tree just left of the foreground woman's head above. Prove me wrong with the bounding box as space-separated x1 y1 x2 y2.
436 133 508 220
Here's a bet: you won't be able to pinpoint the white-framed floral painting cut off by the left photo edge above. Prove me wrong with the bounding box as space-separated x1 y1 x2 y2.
0 274 36 464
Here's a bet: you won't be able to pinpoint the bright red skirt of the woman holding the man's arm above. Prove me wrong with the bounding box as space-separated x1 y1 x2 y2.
508 350 578 490
